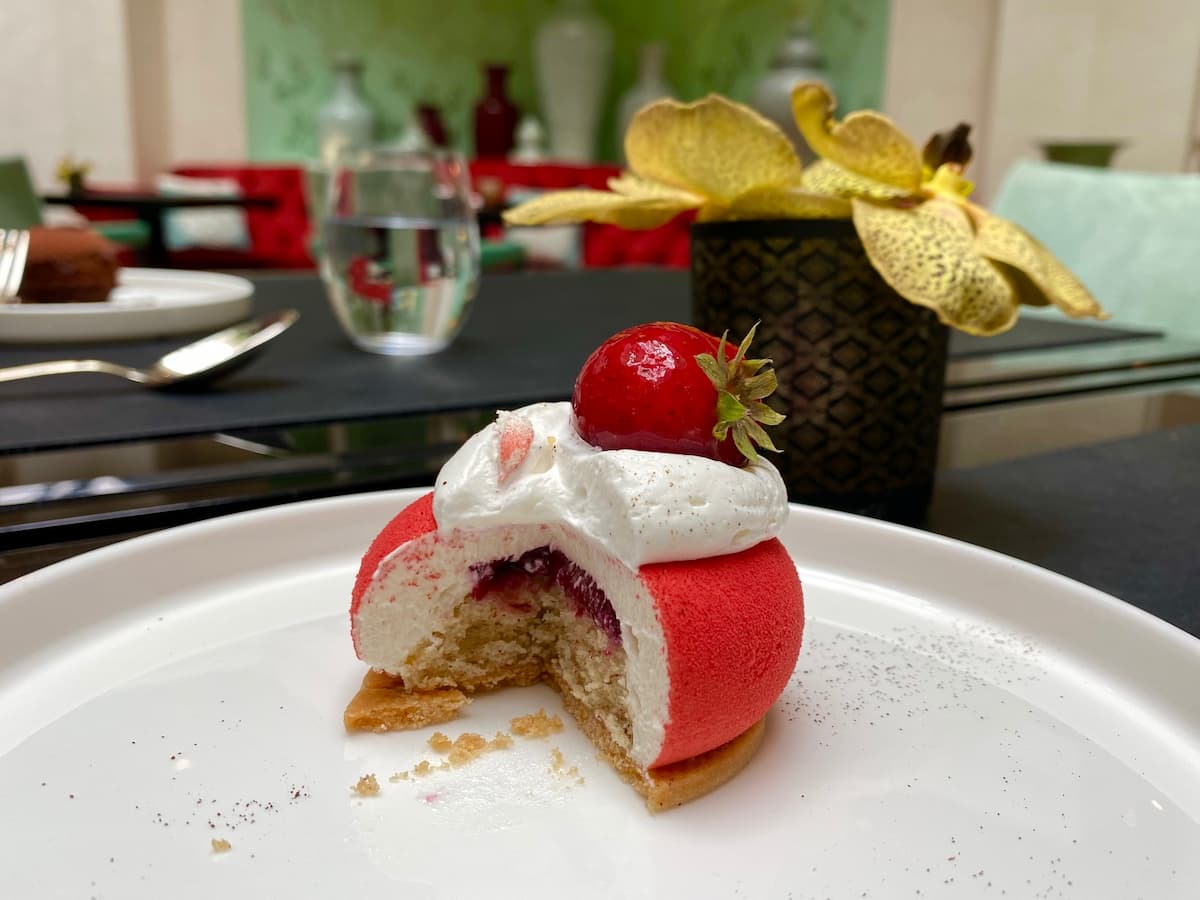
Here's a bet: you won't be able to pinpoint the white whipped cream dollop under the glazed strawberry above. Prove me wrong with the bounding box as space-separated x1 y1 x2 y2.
433 402 787 569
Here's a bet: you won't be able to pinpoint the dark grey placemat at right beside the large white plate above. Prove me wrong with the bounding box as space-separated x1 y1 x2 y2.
925 425 1200 637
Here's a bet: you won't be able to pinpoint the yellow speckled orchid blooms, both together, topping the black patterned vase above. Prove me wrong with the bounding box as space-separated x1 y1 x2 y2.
504 83 1106 335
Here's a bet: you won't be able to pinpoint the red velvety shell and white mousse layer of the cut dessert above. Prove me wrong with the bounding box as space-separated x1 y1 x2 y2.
350 493 804 769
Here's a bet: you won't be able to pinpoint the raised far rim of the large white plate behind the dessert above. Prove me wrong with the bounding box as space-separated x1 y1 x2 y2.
0 488 1200 745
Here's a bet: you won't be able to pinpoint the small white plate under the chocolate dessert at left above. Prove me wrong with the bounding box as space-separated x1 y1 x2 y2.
0 269 254 343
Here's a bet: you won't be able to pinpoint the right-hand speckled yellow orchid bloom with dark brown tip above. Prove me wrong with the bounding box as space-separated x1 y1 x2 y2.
792 83 1108 335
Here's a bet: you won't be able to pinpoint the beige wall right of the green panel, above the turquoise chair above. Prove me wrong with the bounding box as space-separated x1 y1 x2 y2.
884 0 1200 199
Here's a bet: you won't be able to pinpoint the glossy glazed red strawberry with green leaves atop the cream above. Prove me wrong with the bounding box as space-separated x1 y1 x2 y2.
571 322 784 466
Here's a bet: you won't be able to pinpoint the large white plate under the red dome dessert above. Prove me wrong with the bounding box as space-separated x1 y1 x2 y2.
0 492 1200 900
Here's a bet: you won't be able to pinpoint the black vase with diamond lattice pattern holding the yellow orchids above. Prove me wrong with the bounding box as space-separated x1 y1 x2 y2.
691 220 948 522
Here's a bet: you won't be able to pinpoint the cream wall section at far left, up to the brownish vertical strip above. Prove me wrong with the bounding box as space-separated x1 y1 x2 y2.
0 0 136 187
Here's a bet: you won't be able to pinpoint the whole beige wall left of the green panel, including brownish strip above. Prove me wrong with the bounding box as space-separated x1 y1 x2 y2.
0 0 246 188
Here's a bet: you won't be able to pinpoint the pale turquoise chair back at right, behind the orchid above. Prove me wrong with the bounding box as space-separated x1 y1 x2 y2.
991 160 1200 336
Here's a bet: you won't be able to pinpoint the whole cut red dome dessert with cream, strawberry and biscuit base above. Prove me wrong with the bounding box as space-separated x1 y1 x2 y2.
346 323 804 810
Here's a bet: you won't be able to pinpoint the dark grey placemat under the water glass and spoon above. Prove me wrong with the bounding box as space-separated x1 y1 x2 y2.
0 269 1147 452
